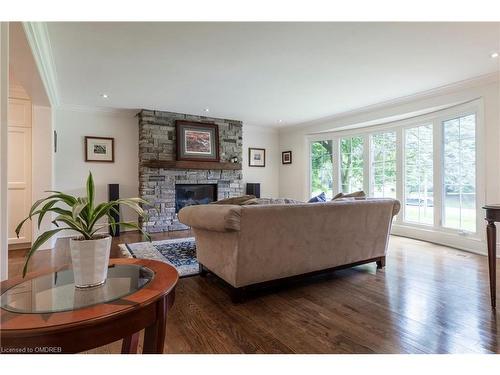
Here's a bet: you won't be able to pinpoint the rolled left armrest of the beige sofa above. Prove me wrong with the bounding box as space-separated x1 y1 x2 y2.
178 204 241 232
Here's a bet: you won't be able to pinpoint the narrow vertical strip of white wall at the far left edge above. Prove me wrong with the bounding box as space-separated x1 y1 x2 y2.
0 22 9 281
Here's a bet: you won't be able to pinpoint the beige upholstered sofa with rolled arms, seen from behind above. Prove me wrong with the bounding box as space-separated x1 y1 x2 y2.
179 198 400 298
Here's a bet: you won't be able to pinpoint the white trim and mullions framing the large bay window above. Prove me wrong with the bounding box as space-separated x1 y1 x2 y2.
307 98 486 253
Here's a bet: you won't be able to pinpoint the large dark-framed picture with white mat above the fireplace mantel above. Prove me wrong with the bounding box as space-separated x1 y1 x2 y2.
175 120 219 162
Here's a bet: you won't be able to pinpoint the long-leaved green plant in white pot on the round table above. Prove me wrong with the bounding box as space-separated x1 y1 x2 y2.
16 173 151 288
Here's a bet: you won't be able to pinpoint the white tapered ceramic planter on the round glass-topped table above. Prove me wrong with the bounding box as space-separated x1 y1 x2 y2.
69 236 111 288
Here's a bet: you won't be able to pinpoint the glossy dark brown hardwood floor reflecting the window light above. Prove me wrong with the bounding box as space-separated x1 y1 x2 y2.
5 232 500 353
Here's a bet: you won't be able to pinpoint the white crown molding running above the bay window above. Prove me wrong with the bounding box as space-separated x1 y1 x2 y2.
279 71 500 131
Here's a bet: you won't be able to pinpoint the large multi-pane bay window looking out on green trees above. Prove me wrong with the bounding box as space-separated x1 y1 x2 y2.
310 102 484 245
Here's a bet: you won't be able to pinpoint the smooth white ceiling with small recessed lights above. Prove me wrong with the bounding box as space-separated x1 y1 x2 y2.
48 22 500 126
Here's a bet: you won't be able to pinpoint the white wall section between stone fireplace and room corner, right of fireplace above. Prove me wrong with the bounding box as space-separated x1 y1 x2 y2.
243 125 281 198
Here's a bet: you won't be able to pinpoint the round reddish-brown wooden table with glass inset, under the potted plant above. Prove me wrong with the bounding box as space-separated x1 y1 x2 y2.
0 258 179 354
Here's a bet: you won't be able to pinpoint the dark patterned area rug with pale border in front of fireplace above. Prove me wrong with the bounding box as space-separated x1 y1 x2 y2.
119 237 200 277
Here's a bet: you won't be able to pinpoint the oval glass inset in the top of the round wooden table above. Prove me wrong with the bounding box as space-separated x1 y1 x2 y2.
1 264 154 313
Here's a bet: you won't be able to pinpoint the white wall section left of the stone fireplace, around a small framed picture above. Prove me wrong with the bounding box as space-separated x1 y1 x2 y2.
54 109 139 233
